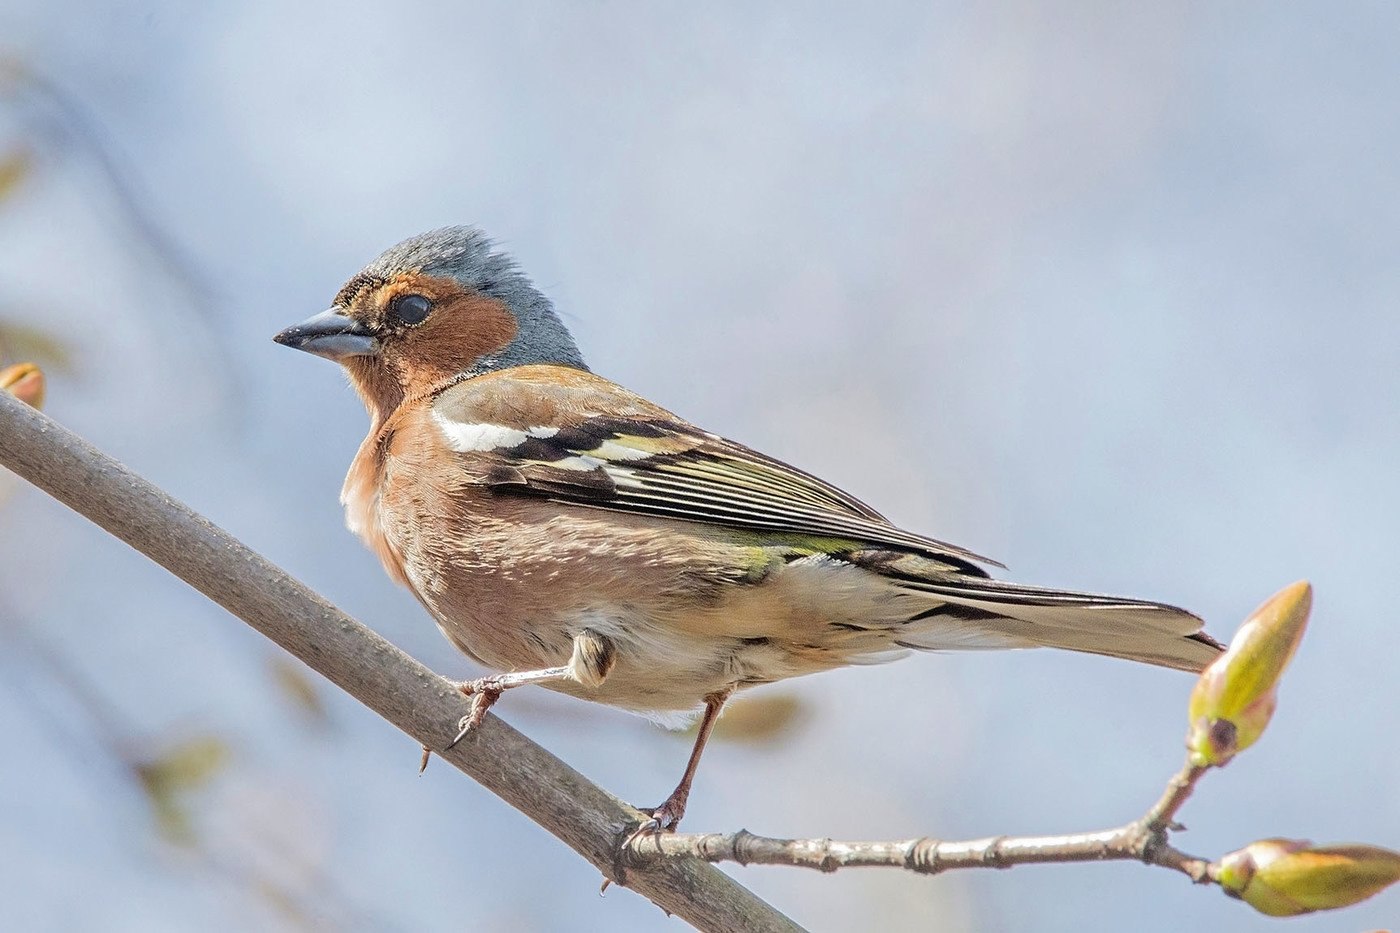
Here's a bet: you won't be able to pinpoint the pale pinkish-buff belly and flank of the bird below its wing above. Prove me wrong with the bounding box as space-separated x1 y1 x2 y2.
375 504 927 712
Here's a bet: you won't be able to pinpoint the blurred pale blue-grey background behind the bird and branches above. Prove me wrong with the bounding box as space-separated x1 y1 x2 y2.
0 0 1400 932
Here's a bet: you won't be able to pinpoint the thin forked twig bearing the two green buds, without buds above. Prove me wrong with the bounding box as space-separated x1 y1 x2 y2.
627 763 1215 884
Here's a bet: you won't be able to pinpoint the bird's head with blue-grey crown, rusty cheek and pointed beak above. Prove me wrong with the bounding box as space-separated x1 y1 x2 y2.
273 227 587 419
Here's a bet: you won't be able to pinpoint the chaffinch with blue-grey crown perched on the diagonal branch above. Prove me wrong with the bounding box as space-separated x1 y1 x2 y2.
274 227 1221 829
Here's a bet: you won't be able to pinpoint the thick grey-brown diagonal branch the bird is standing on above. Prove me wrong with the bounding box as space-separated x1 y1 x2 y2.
0 392 799 930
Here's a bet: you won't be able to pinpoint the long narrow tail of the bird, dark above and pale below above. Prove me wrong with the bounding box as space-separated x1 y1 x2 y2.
899 577 1225 671
